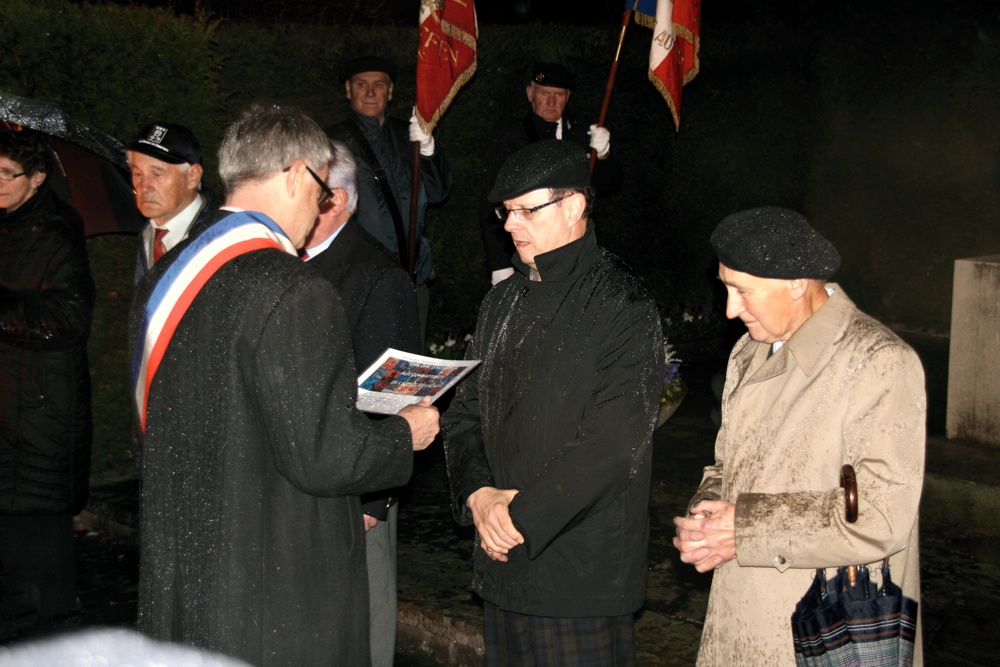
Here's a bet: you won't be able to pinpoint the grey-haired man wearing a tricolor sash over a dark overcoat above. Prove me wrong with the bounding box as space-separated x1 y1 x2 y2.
129 105 437 667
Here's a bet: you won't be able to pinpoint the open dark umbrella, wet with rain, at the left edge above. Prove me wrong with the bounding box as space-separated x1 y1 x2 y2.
0 91 145 236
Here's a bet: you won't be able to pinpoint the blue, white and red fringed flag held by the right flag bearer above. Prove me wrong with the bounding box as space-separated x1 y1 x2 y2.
625 0 701 130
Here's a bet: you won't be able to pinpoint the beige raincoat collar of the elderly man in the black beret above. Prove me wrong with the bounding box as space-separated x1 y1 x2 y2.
741 283 855 382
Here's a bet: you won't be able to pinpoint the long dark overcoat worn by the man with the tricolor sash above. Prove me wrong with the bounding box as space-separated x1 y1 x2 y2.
130 213 413 667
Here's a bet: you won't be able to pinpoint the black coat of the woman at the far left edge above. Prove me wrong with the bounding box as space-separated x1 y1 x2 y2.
0 185 94 514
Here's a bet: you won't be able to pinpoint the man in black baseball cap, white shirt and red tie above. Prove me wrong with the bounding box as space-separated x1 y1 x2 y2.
125 122 219 283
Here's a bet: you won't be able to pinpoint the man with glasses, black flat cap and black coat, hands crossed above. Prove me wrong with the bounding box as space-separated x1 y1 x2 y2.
443 141 663 665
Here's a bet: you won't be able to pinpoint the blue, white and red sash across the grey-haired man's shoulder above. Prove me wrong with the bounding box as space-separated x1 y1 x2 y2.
132 211 296 433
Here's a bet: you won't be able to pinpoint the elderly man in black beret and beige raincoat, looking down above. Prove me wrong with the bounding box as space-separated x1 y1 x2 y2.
674 207 926 666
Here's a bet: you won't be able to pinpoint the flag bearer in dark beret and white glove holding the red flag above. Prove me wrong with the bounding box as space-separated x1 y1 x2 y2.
328 56 451 338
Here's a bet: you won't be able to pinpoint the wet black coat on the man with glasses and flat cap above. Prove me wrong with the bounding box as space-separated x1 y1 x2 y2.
442 224 663 617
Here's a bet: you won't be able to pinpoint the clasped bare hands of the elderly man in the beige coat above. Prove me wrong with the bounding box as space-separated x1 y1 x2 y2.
674 500 736 572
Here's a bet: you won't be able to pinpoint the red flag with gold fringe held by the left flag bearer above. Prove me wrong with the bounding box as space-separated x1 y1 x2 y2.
416 0 479 133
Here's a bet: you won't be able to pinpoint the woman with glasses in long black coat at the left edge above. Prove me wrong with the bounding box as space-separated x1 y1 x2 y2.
0 128 94 632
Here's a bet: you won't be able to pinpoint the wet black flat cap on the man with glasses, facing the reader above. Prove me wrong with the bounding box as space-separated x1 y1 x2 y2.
489 139 590 202
